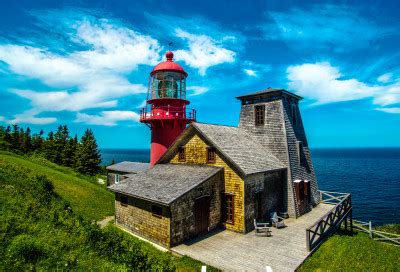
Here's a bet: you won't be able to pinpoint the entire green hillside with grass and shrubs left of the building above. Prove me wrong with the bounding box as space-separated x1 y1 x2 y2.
0 151 217 271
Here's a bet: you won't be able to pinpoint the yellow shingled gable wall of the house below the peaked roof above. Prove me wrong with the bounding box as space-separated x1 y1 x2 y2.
170 135 244 232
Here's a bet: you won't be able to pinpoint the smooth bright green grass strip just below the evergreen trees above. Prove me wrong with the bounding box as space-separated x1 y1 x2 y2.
0 151 114 220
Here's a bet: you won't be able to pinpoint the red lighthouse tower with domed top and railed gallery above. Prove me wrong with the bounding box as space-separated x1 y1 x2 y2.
140 51 196 165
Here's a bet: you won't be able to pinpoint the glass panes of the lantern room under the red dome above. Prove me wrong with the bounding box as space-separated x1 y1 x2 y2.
149 72 186 99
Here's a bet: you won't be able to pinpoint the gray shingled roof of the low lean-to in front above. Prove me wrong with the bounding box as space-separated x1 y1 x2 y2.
108 164 222 205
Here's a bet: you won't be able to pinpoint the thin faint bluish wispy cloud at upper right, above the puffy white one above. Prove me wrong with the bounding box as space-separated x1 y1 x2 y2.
261 4 394 51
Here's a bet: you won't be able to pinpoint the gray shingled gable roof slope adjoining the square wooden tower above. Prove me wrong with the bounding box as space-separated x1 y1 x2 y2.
192 123 286 175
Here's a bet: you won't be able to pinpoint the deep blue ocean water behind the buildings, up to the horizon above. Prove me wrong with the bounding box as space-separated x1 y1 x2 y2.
101 148 400 225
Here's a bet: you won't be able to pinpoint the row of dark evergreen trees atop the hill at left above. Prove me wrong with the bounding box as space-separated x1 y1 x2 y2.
0 124 101 175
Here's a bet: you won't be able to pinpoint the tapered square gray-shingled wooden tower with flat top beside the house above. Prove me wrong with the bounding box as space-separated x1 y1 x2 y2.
237 88 320 217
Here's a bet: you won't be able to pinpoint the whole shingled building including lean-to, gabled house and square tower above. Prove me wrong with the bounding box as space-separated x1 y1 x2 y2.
109 86 319 248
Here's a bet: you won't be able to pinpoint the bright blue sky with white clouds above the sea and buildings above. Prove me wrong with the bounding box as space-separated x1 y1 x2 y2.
0 0 400 148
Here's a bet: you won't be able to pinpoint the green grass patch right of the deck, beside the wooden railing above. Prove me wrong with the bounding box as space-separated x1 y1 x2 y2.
299 228 400 271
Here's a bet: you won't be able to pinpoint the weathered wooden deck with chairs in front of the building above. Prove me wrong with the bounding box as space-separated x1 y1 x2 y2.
171 204 333 272
